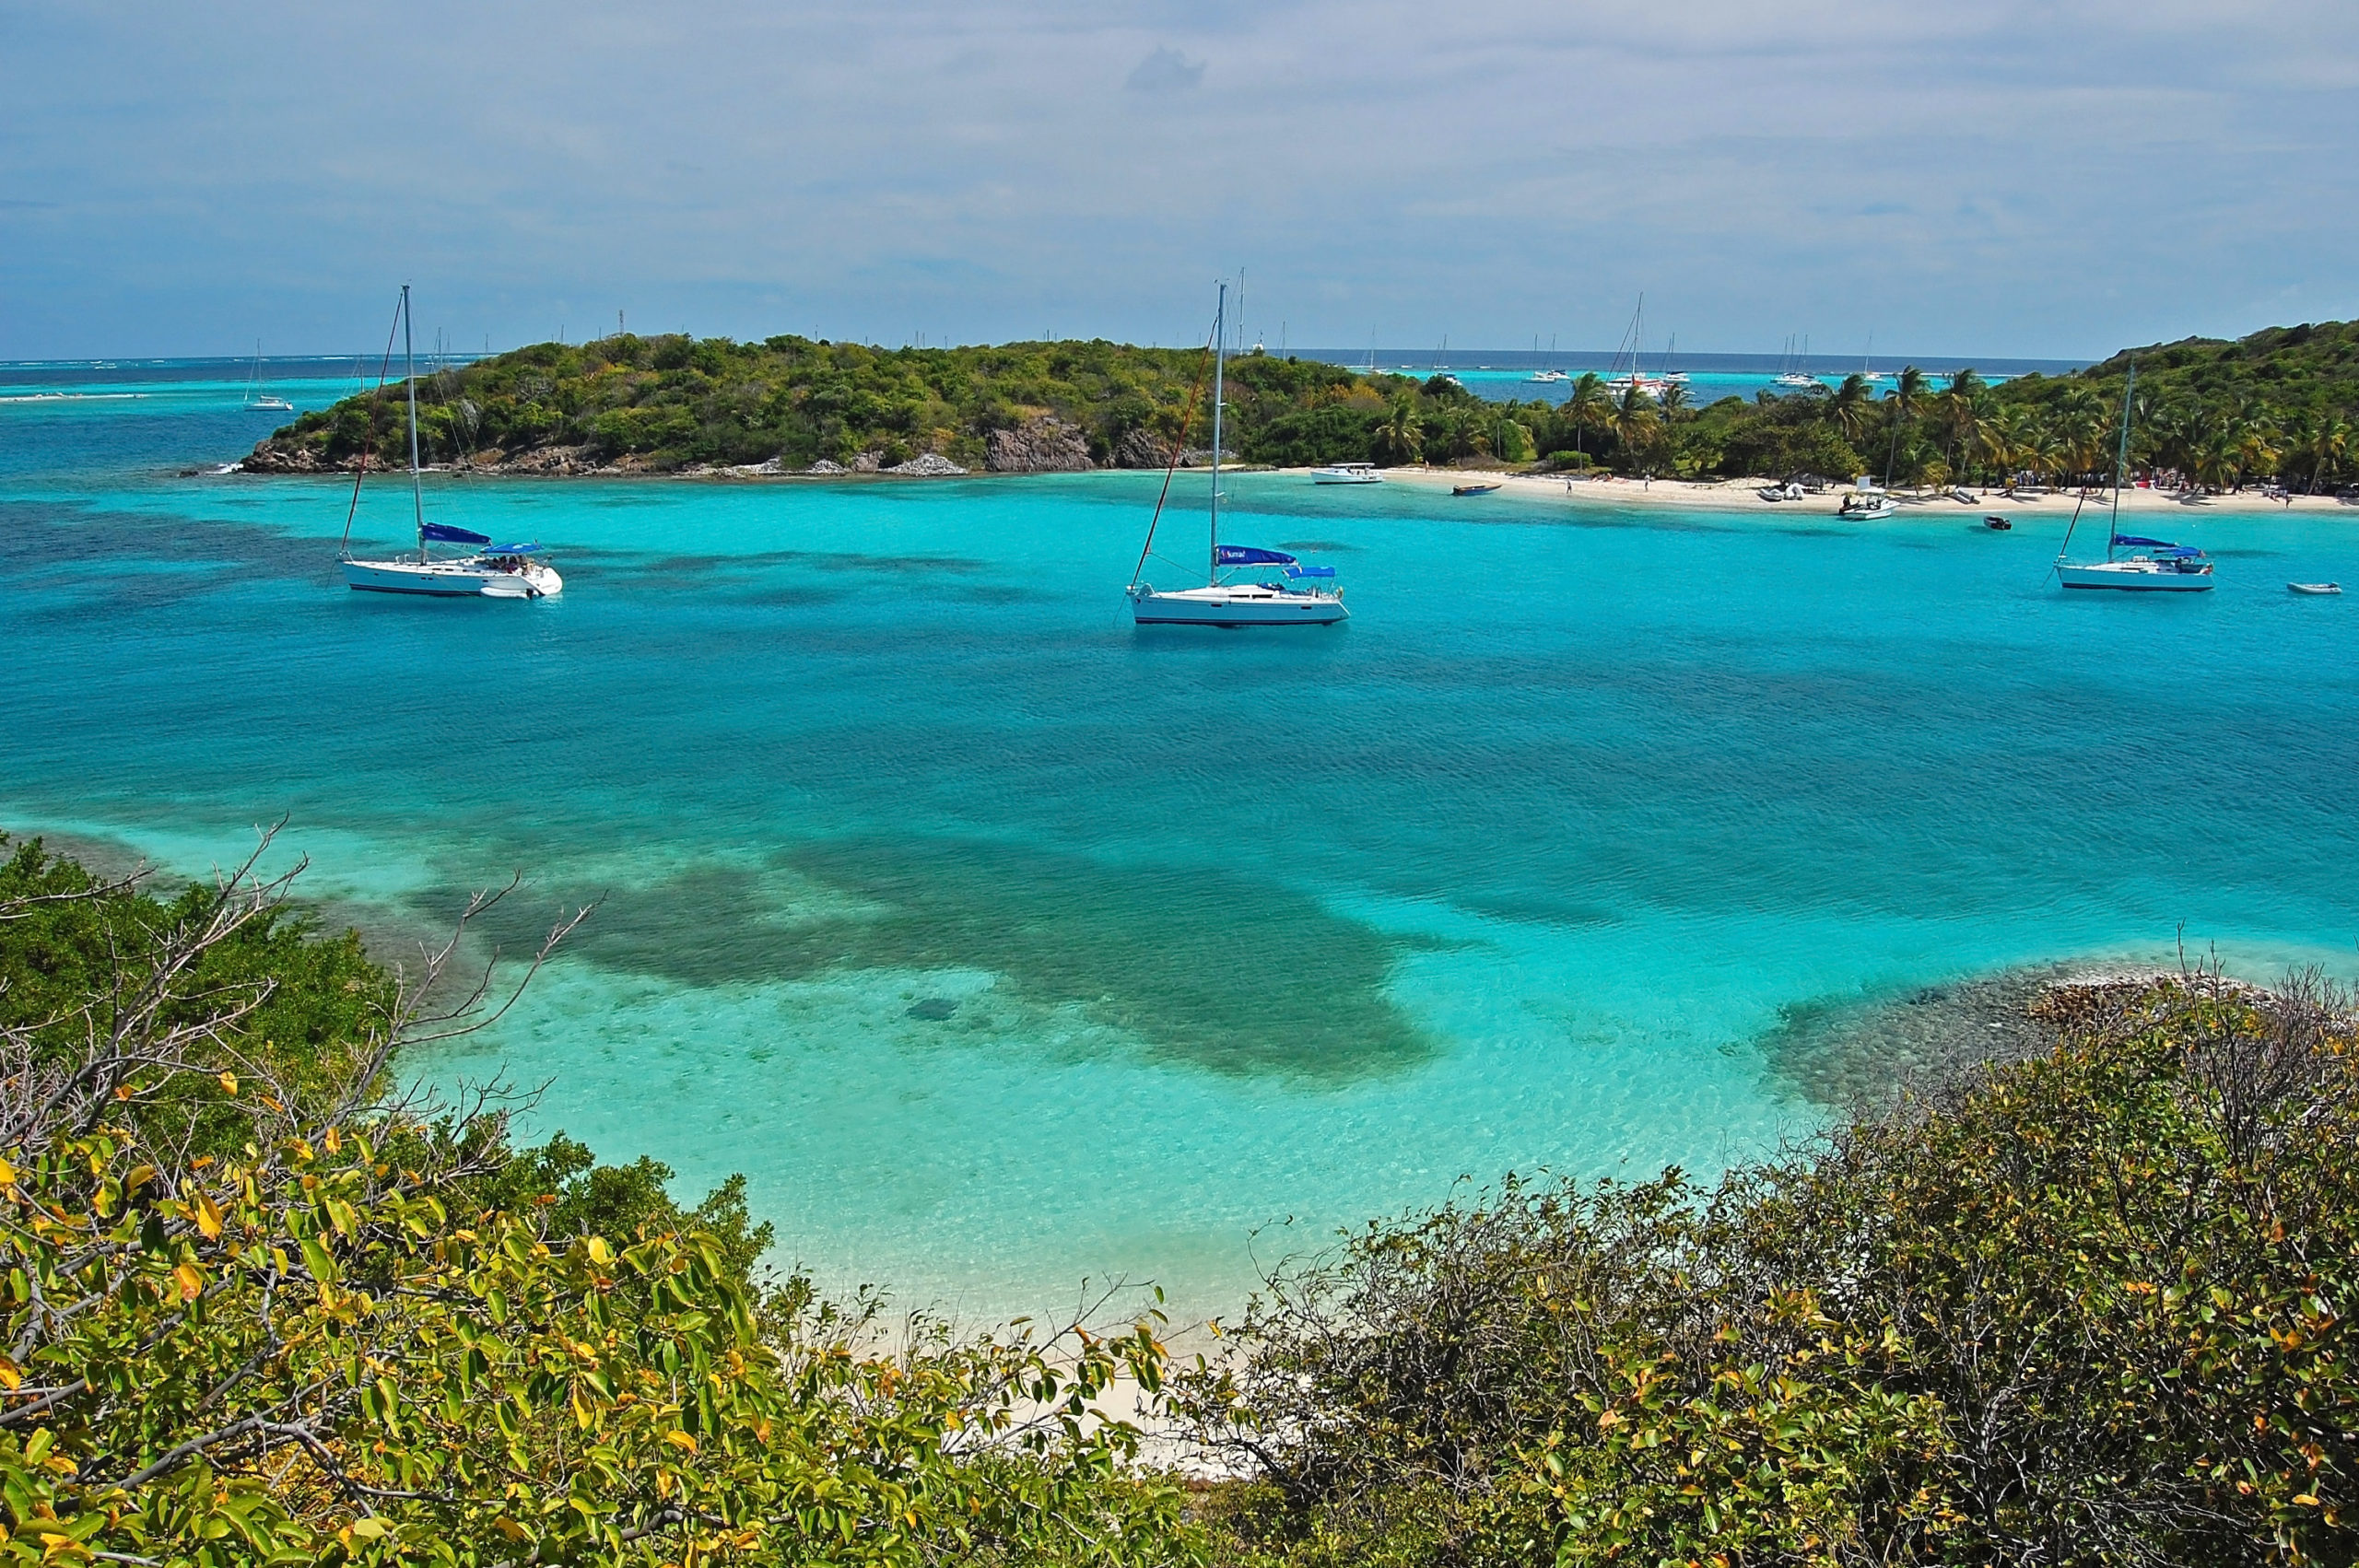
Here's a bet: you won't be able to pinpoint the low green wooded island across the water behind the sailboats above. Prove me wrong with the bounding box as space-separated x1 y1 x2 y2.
245 323 2359 490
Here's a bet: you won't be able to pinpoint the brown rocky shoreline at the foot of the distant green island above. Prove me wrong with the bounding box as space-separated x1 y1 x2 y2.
231 415 1236 479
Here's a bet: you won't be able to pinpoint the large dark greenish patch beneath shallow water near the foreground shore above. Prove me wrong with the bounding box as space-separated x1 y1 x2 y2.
422 839 1437 1082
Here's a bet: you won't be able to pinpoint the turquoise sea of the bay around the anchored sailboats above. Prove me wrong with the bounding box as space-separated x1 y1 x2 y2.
0 370 2359 1318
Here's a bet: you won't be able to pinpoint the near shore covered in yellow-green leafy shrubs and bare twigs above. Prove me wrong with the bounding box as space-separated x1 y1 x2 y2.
0 825 2359 1568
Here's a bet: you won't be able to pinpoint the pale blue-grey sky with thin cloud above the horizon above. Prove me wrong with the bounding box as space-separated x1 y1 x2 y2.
0 0 2359 363
